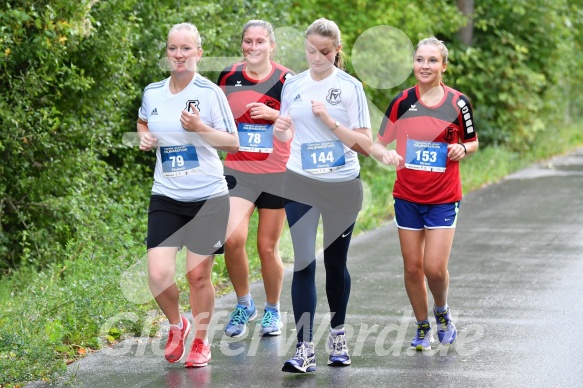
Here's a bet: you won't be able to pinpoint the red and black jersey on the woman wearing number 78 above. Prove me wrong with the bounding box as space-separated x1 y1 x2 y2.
218 61 293 174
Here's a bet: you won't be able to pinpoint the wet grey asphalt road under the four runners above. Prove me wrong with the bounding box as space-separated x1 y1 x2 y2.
29 149 583 387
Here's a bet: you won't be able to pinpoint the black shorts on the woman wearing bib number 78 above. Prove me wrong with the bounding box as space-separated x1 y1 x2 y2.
225 167 285 209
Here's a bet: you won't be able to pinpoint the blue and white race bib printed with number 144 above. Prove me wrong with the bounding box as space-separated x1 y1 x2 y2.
301 140 346 174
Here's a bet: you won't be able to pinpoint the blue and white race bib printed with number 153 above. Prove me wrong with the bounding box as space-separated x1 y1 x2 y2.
405 139 447 172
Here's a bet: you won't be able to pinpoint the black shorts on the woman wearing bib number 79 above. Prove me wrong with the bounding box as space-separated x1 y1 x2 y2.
146 194 230 255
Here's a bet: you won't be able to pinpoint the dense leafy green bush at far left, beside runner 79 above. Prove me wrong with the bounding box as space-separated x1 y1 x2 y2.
0 0 137 270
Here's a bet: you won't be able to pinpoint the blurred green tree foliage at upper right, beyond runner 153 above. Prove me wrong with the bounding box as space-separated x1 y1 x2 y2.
452 0 581 151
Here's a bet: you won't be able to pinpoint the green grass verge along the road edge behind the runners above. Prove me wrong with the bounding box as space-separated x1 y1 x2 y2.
0 121 583 387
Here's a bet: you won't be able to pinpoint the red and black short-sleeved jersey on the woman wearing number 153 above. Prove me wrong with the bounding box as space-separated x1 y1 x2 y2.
377 84 478 204
